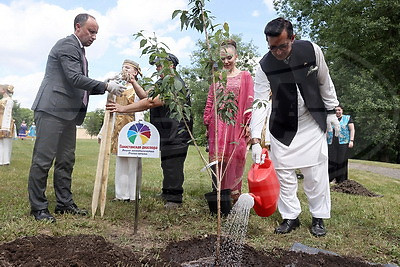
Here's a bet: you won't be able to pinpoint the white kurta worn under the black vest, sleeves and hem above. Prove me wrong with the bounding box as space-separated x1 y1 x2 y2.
250 44 339 169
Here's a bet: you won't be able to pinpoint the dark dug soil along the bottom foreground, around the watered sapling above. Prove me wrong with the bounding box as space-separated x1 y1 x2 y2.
0 235 382 267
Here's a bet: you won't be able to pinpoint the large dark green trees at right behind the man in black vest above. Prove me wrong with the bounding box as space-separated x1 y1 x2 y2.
274 0 400 163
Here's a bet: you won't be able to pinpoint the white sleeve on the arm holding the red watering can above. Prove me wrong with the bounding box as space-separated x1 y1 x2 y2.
250 64 271 138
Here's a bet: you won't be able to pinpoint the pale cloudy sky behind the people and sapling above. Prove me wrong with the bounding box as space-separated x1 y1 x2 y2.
0 0 277 110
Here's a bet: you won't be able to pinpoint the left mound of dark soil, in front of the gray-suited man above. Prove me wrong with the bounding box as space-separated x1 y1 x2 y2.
0 235 162 267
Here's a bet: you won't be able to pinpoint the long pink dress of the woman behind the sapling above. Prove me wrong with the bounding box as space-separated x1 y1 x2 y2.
204 71 254 194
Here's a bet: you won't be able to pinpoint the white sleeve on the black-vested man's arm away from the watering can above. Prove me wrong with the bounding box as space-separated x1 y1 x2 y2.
312 43 339 110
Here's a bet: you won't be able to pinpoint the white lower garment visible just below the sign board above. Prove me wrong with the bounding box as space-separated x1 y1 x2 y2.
115 157 142 200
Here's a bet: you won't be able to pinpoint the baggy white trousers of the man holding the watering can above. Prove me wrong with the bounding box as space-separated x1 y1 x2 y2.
276 160 331 219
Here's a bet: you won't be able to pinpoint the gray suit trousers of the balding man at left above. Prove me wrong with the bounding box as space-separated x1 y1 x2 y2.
28 112 76 213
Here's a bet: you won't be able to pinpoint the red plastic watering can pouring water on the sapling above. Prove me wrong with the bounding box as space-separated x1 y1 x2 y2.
247 148 280 217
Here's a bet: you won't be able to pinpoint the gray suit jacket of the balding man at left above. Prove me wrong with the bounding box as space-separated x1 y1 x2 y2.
32 34 106 125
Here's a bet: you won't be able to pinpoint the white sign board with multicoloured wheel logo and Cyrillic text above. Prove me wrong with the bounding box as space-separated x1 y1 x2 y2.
118 121 160 158
